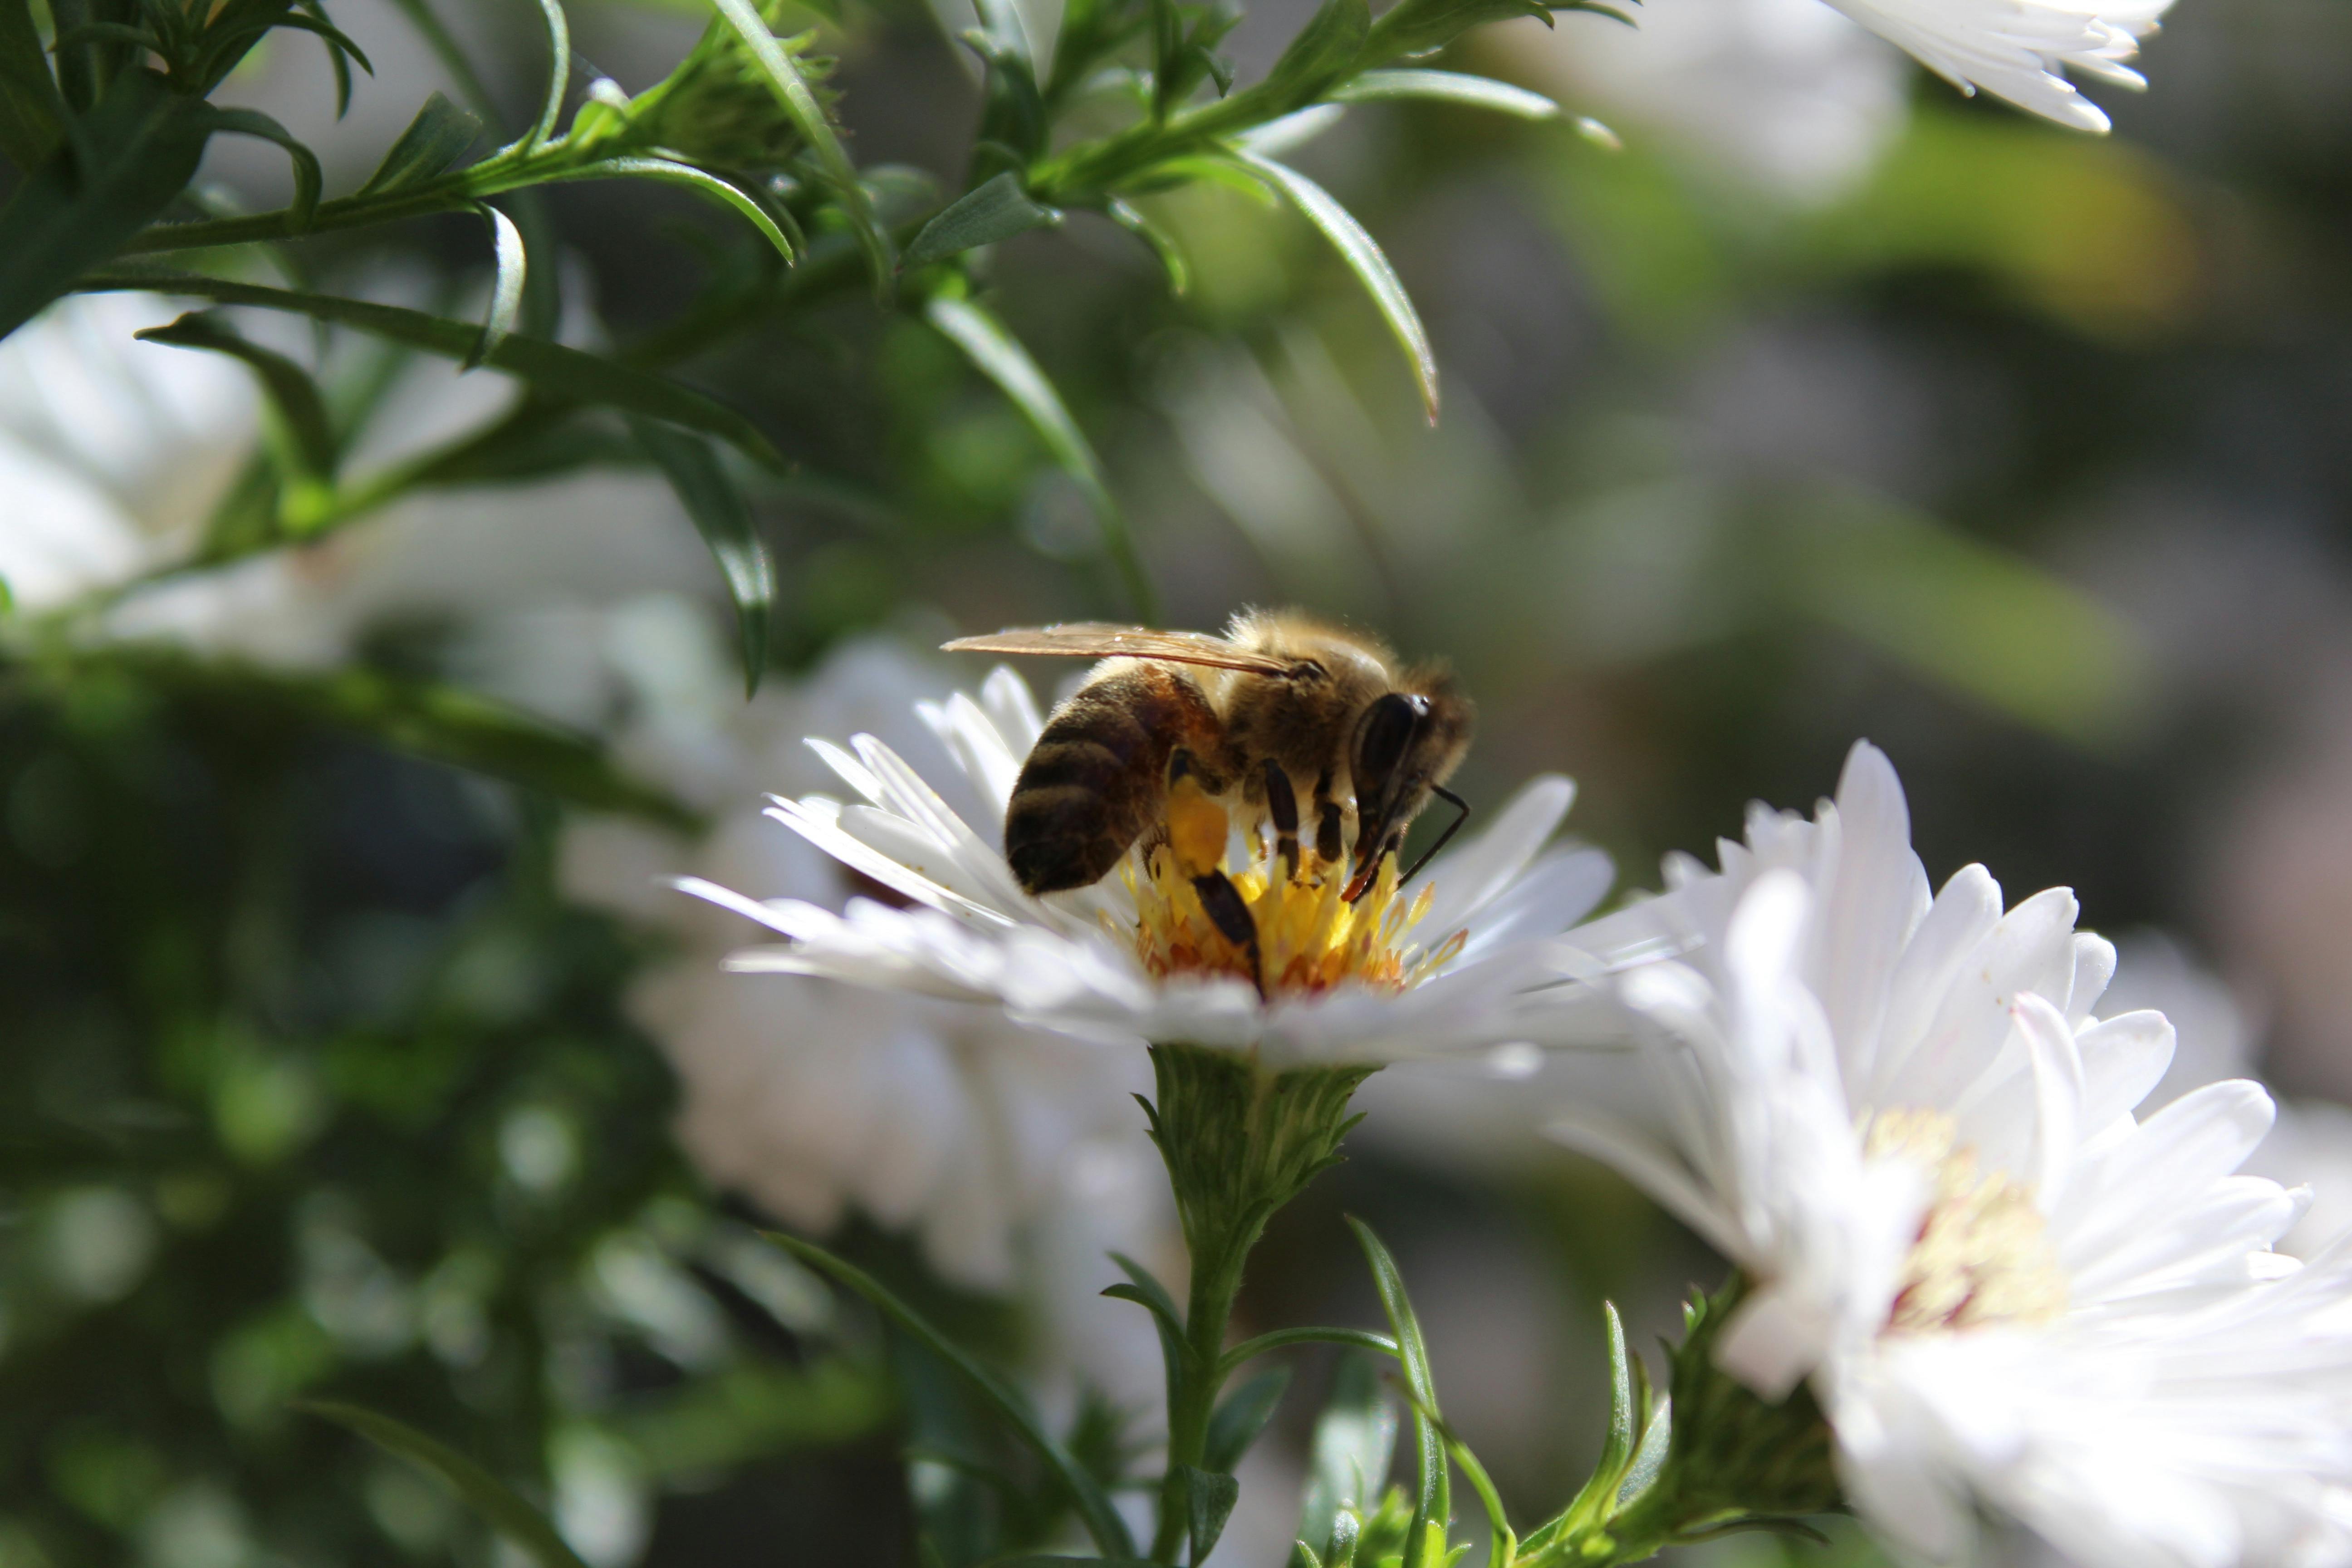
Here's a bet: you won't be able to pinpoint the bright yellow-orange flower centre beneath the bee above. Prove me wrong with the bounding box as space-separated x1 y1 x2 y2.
1120 778 1470 999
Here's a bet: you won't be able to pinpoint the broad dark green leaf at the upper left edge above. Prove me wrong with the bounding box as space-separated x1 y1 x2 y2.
0 70 214 336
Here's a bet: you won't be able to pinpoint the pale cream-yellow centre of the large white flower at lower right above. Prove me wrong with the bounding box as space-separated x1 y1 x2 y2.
1863 1107 2068 1335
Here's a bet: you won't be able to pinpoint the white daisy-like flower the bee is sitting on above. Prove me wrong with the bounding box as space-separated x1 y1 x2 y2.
680 668 1611 1070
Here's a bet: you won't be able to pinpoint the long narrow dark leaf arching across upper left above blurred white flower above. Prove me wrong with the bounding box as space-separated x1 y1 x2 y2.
78 268 790 472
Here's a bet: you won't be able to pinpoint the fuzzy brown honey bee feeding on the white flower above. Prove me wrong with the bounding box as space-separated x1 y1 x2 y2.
946 611 1472 912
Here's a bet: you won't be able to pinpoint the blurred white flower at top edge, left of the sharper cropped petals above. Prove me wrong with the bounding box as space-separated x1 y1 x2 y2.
1482 0 1910 202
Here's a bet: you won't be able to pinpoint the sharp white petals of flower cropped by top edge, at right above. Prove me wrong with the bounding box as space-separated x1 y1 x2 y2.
1830 0 2171 132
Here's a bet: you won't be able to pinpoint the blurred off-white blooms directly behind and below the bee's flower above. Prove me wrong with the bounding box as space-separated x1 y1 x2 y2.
564 644 1183 1399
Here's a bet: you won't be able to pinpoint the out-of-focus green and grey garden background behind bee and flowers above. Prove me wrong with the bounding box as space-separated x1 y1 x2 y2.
0 0 2352 1568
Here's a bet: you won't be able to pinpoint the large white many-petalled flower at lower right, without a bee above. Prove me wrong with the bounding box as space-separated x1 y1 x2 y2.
1557 745 2352 1568
